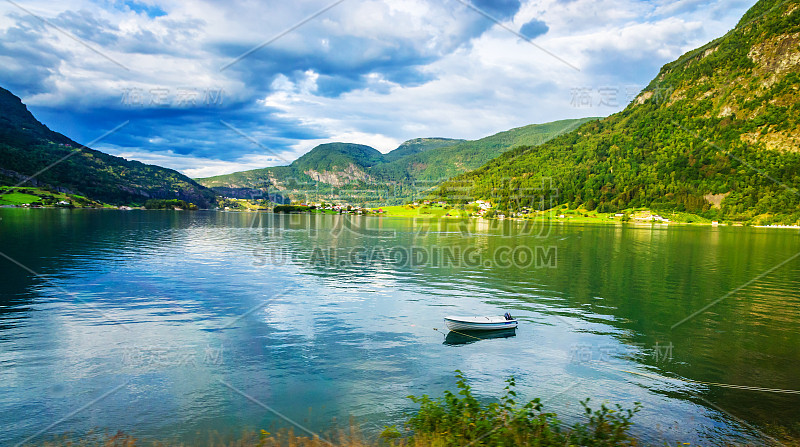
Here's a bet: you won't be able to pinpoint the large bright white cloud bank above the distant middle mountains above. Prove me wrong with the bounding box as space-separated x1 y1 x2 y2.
252 0 756 154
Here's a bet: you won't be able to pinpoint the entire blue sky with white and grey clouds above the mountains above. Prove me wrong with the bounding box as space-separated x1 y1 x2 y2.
0 0 755 177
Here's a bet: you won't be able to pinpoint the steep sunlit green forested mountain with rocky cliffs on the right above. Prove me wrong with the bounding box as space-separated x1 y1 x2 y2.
436 0 800 222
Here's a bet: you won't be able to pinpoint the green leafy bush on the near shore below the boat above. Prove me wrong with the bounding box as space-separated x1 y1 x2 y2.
394 371 641 446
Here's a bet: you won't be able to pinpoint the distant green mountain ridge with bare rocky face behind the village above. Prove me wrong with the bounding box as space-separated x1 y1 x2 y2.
197 118 597 203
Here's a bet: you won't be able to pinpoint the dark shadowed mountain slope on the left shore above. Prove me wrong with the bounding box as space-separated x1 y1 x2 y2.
0 88 216 207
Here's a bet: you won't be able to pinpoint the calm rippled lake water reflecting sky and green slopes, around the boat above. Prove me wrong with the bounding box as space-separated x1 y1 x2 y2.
0 209 800 445
